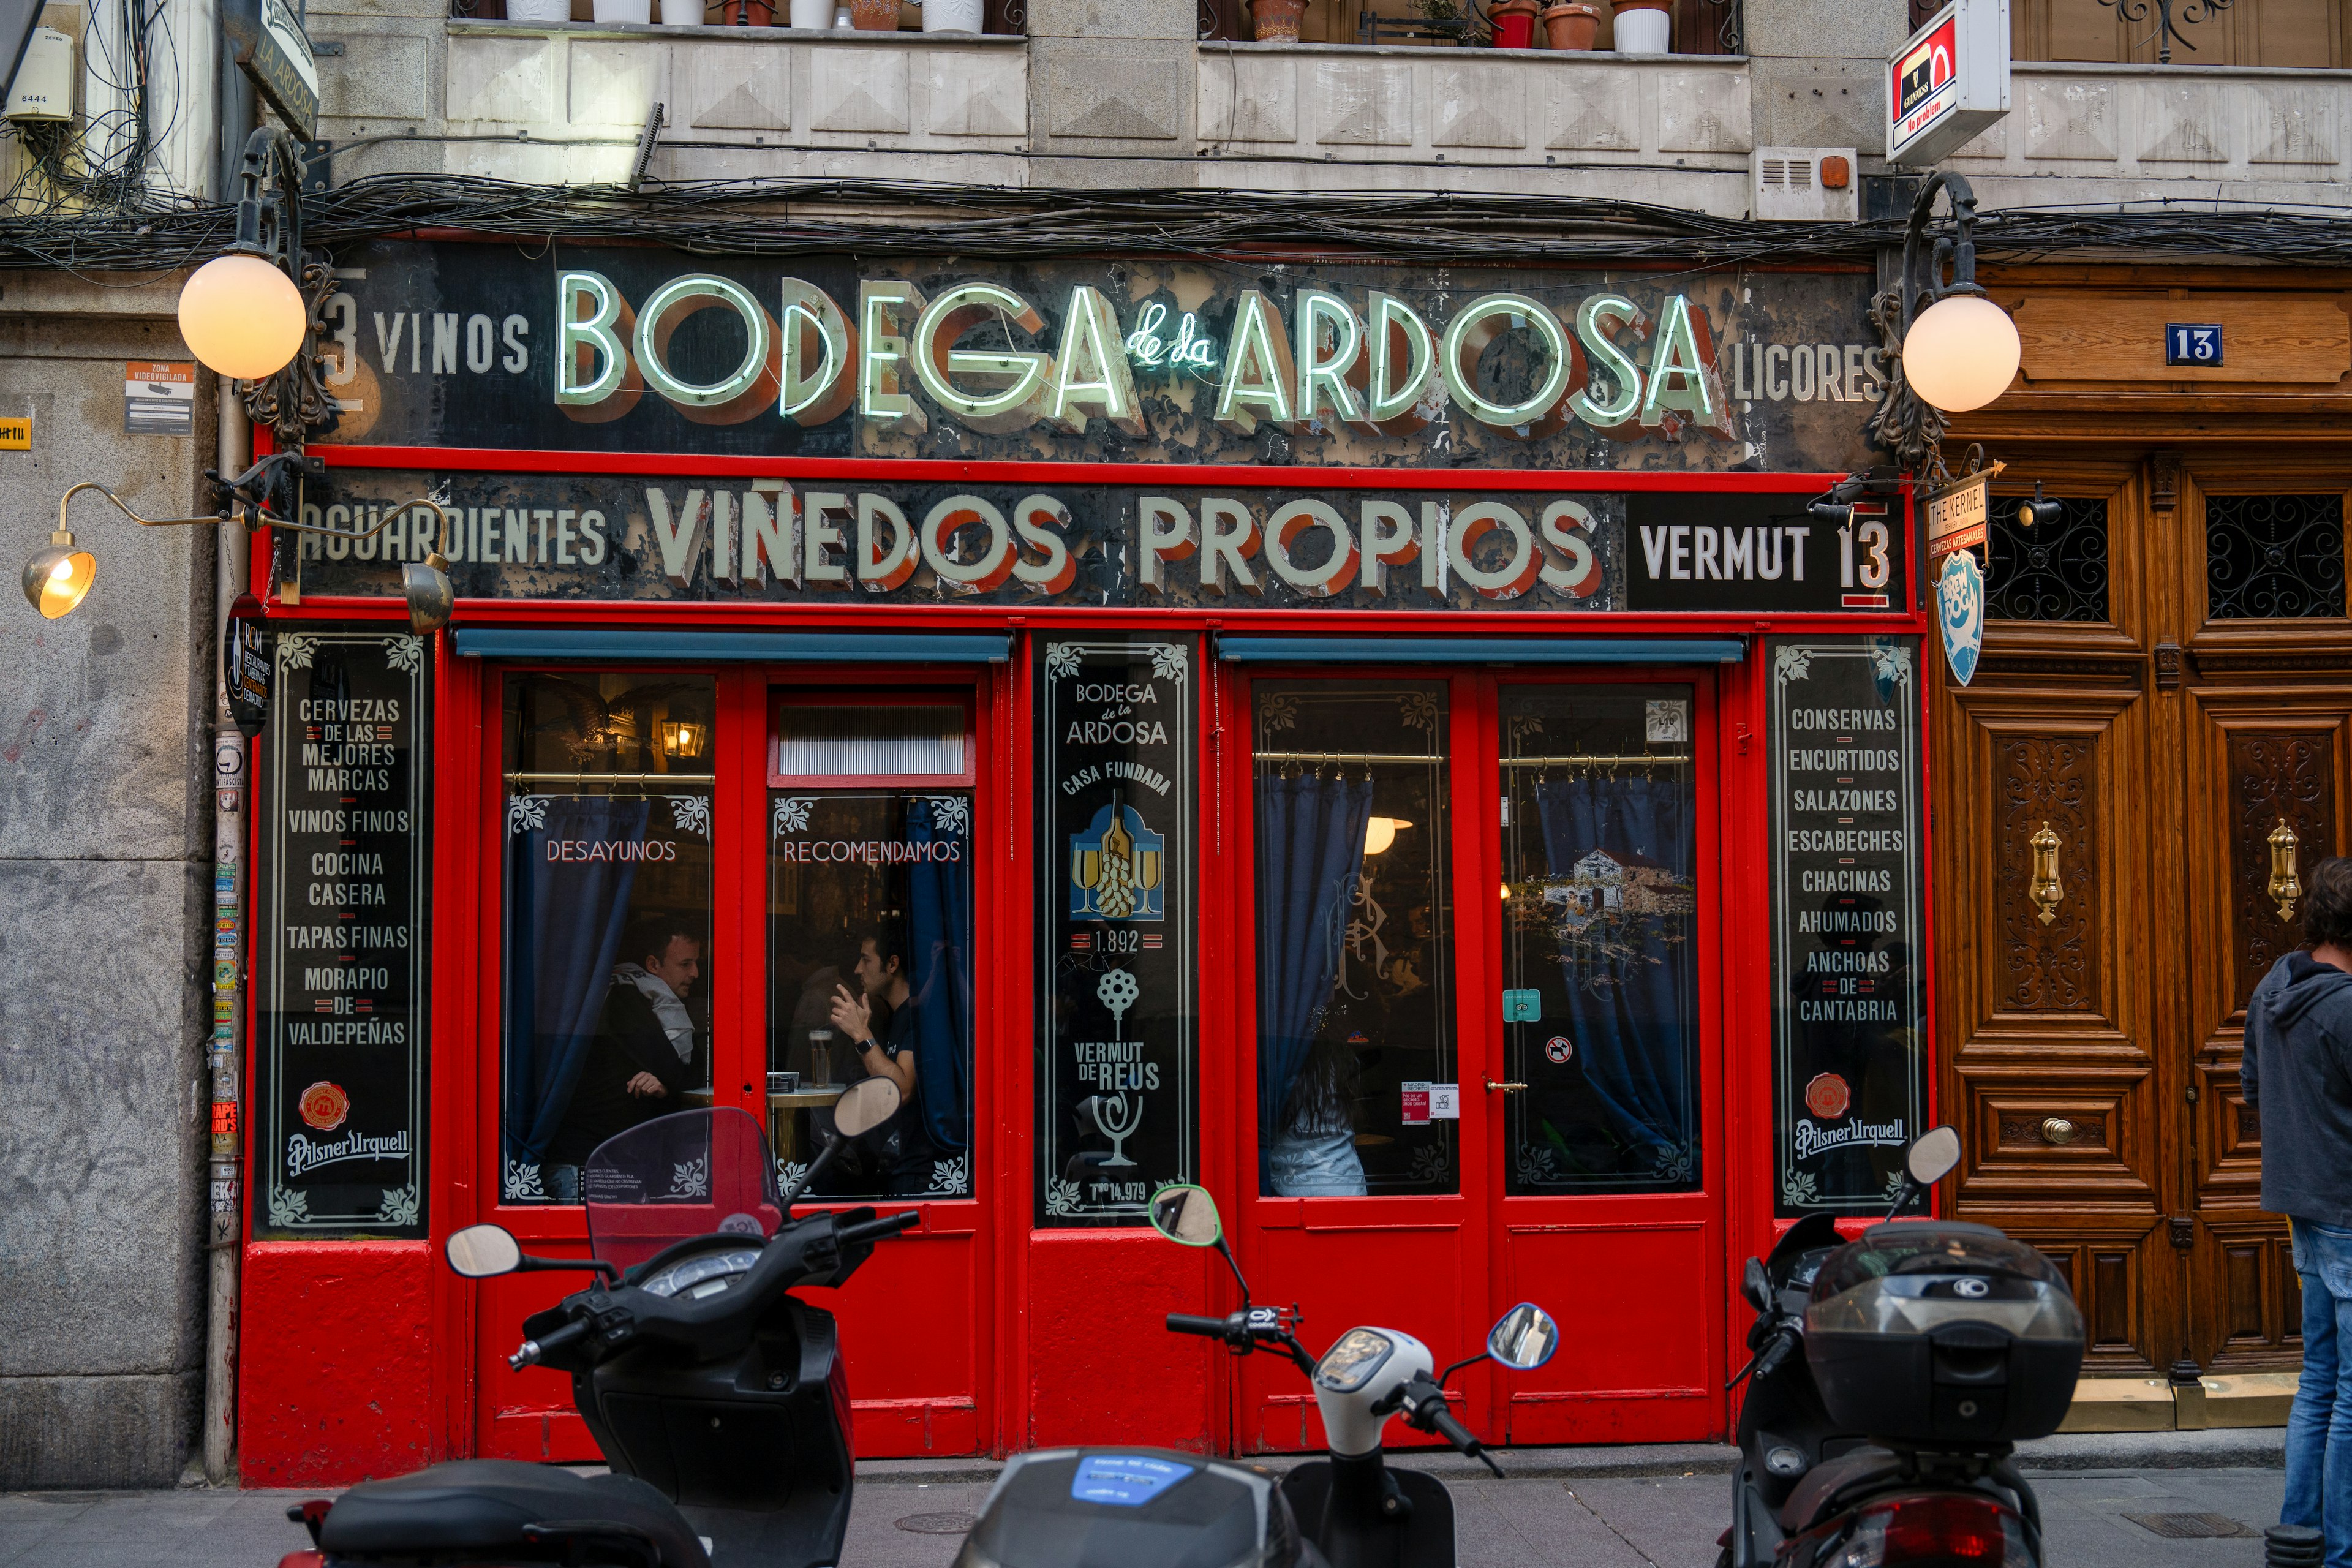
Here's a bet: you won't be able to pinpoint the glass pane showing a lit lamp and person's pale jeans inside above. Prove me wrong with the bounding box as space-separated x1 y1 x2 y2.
1256 682 1461 1197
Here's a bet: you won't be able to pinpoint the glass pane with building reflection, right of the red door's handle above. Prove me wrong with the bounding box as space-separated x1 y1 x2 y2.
1503 687 1700 1197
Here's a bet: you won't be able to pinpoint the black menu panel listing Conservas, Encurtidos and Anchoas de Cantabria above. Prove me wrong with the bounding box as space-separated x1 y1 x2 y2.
1769 637 1926 1215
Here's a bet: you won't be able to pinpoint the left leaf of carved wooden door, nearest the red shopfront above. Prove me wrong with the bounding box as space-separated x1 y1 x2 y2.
1936 673 2178 1373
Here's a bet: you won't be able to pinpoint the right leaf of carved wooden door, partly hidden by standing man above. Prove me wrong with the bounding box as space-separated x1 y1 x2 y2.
2180 682 2352 1371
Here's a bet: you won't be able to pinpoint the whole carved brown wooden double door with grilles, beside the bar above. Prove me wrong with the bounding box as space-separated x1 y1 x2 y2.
1933 444 2352 1382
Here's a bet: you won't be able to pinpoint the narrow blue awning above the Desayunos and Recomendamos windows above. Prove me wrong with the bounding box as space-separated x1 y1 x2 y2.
456 625 1011 665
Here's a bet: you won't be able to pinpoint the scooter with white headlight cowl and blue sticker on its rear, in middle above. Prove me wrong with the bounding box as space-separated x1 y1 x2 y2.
955 1185 1559 1568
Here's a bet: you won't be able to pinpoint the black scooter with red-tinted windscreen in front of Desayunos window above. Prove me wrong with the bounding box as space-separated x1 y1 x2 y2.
280 1079 919 1568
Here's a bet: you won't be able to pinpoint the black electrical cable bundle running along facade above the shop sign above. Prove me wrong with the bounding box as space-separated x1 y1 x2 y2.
0 170 2352 270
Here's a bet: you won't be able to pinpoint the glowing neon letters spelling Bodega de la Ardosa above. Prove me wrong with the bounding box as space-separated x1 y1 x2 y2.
552 270 1731 442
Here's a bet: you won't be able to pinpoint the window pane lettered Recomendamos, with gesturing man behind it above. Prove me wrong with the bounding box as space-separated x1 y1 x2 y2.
767 785 971 1199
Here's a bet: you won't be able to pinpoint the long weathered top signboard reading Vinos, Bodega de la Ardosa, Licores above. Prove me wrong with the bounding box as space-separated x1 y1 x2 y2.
322 242 1887 472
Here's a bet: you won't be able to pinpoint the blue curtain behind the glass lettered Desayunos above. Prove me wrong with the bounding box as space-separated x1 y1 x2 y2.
501 797 652 1166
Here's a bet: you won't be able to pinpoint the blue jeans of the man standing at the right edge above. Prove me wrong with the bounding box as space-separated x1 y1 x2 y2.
2279 1220 2352 1568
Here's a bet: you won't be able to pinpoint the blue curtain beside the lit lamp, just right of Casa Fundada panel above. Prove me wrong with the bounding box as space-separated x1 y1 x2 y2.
1258 774 1371 1138
